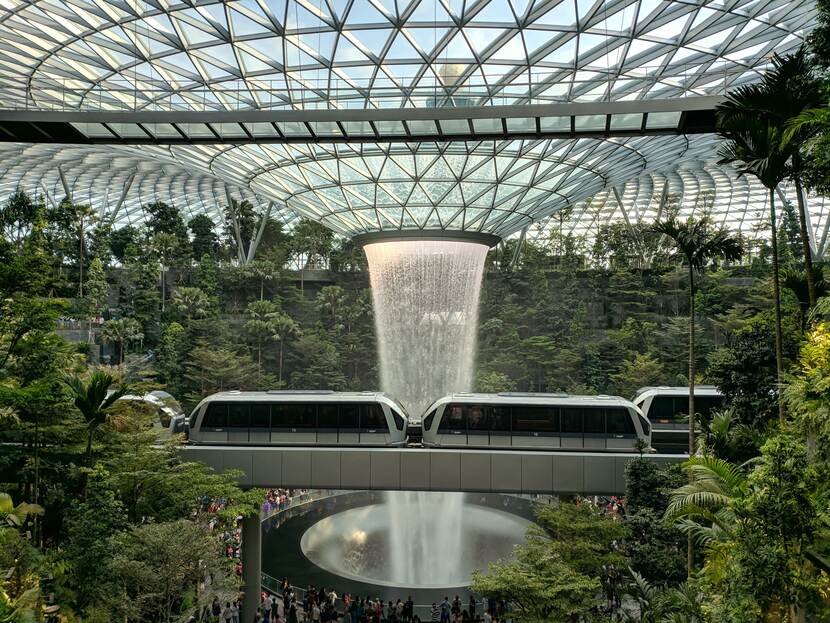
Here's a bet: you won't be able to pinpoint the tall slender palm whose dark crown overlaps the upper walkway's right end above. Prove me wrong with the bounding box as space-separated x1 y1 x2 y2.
717 94 792 422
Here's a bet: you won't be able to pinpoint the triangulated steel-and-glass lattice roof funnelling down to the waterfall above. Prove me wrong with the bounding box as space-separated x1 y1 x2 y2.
0 0 814 236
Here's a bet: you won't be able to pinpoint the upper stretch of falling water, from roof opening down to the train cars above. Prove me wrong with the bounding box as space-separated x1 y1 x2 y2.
364 240 487 417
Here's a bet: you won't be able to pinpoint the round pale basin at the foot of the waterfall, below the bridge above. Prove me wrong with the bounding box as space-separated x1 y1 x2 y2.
300 491 532 589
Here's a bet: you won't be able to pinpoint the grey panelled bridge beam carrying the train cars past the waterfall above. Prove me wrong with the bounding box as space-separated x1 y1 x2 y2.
180 445 687 495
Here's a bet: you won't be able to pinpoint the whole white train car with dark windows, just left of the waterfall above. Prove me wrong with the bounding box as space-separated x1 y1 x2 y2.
188 391 407 446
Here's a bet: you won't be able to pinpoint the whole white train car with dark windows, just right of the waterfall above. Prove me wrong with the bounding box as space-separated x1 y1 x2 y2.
422 392 651 451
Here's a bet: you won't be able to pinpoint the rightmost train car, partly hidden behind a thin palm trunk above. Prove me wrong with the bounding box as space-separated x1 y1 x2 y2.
632 385 723 453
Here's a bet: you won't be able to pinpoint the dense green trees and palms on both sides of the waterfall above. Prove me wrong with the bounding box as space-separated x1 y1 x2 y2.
0 2 830 623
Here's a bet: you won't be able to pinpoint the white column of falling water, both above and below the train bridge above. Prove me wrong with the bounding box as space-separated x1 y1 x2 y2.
364 240 487 584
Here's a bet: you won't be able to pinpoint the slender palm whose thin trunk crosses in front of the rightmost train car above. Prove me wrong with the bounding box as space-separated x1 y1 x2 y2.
653 217 743 455
